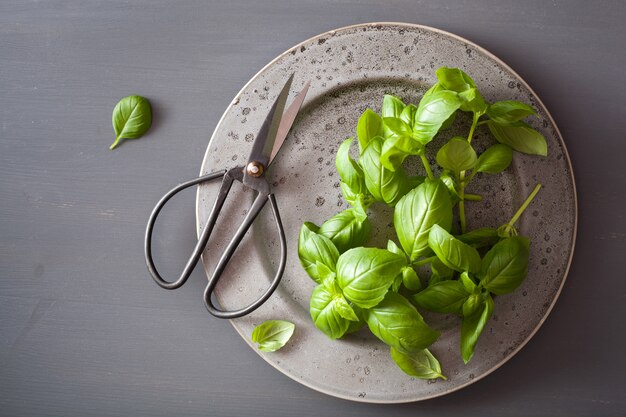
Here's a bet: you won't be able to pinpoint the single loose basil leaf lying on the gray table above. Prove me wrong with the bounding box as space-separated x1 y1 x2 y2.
109 96 152 150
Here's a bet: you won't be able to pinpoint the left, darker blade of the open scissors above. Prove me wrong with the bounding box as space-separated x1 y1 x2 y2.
248 74 294 168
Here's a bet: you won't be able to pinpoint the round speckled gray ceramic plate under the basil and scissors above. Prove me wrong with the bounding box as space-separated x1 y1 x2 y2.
197 23 576 403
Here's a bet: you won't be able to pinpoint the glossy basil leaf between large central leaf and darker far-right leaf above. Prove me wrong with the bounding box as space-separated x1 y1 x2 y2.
428 224 480 273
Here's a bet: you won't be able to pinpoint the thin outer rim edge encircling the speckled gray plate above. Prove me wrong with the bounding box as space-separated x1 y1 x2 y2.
196 22 578 404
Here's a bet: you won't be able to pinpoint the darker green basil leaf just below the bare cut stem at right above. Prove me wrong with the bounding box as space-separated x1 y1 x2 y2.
480 236 530 295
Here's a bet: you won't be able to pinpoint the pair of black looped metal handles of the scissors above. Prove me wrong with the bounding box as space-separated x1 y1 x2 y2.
144 167 287 319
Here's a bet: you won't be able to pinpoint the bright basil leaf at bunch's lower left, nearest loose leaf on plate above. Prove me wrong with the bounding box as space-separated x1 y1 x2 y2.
309 285 350 339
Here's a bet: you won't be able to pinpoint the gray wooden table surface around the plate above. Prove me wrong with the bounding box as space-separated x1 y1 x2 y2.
0 0 626 416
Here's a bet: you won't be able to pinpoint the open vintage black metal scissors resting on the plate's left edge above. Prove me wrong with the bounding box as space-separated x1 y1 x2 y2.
145 74 310 319
